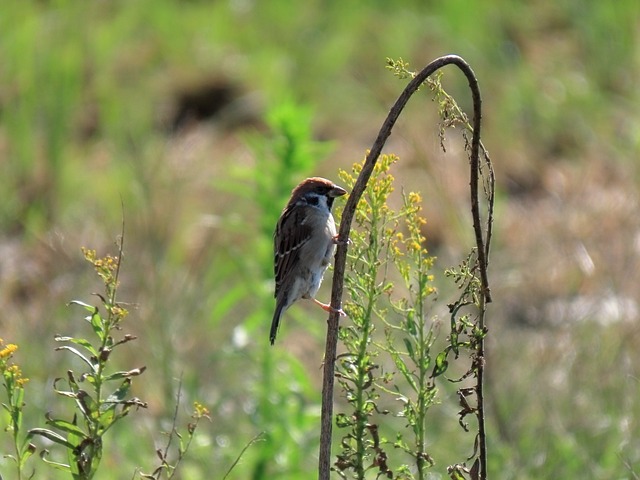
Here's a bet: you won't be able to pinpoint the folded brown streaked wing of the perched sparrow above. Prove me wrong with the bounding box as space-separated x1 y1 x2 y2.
273 205 313 297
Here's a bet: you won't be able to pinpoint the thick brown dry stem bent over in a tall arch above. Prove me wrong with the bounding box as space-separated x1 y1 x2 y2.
318 55 493 480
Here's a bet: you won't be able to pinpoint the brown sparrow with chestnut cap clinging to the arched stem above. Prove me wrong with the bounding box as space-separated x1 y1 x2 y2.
269 177 347 345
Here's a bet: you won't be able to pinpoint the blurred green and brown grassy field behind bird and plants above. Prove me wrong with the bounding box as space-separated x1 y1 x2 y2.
0 0 640 479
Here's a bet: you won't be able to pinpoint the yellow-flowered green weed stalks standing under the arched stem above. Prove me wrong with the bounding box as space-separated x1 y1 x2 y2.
335 155 437 479
